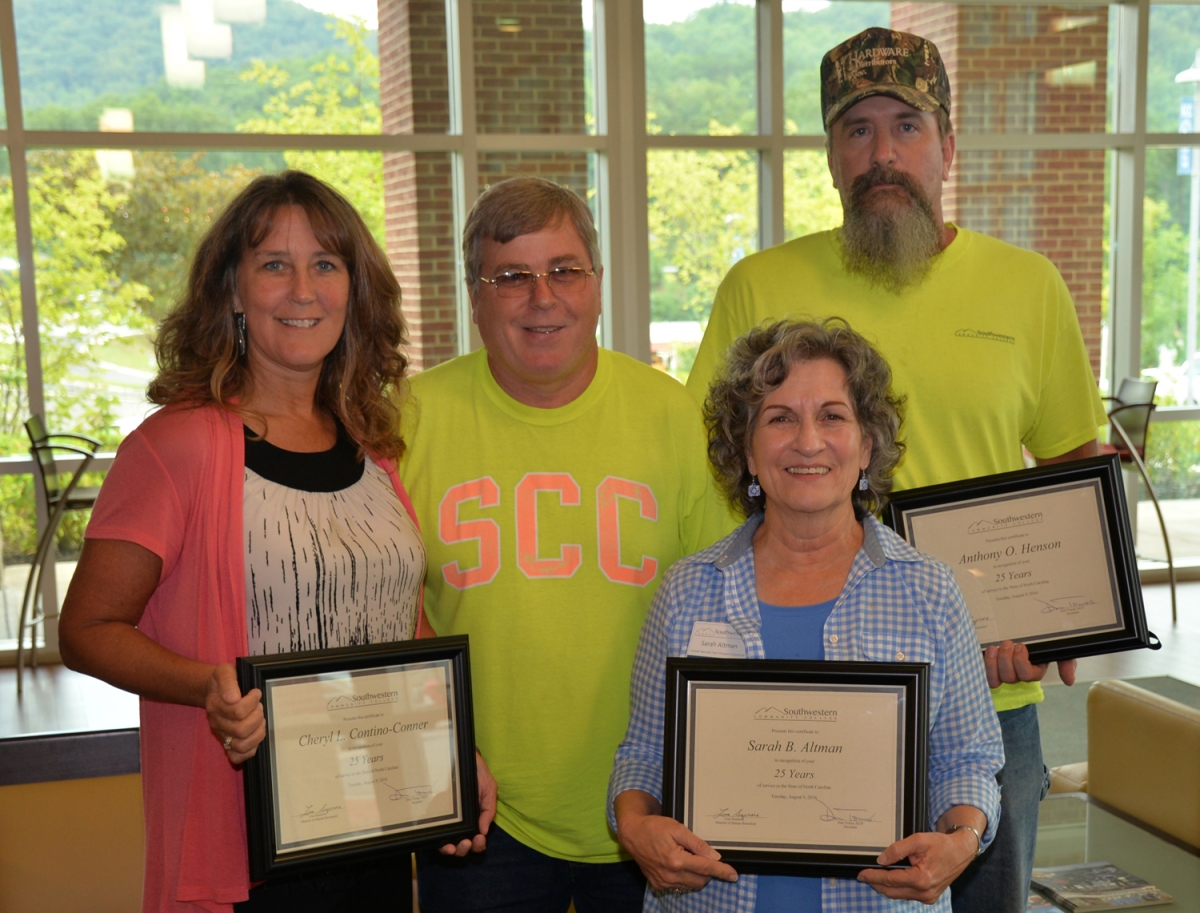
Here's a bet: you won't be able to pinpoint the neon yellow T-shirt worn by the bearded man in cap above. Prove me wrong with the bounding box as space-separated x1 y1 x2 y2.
688 228 1106 710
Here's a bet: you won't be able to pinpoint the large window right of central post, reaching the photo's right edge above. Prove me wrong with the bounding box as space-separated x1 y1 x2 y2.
643 0 1200 563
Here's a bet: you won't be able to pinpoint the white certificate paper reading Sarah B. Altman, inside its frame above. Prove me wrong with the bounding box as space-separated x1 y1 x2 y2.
684 681 905 853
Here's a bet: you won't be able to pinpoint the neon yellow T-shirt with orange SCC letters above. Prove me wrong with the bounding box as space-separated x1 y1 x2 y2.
400 350 733 863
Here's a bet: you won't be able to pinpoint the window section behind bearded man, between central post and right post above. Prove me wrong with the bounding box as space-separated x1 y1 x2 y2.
643 0 1118 376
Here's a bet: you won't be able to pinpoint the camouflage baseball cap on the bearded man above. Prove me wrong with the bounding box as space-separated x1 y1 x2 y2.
821 29 950 130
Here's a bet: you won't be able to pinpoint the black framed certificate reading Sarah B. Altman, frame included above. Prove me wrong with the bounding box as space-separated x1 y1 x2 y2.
662 657 929 878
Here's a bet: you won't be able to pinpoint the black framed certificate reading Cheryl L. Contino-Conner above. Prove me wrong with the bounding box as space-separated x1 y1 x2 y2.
238 637 479 881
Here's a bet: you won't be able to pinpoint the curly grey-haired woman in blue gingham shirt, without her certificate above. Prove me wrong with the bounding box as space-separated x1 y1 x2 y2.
608 320 1004 913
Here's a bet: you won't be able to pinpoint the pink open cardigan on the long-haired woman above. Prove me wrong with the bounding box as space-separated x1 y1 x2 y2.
86 406 428 913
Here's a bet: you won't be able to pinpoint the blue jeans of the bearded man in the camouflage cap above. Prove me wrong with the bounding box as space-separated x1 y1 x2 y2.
950 704 1050 913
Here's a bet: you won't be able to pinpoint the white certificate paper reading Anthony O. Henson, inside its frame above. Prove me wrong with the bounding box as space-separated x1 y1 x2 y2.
905 479 1122 645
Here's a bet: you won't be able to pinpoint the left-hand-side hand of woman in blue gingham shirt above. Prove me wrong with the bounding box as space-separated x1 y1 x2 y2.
614 789 738 893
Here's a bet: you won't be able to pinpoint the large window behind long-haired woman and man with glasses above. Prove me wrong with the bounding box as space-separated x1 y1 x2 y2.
0 0 612 649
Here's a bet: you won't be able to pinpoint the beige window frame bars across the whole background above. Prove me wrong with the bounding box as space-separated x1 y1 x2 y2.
0 0 1200 654
